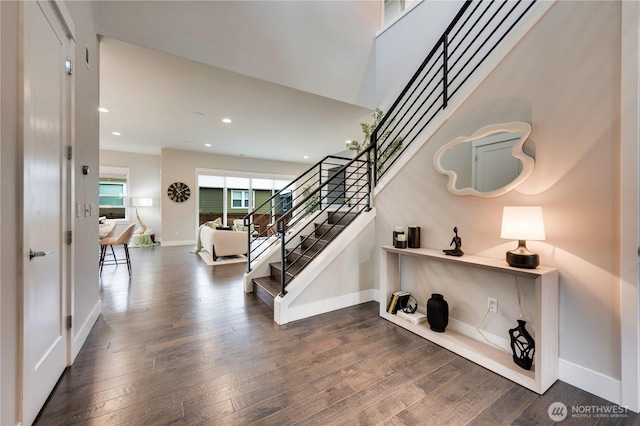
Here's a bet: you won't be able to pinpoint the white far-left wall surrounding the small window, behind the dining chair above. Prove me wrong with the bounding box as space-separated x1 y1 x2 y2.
100 150 164 241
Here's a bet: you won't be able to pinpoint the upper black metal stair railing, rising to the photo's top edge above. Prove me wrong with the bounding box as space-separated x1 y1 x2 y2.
371 0 536 186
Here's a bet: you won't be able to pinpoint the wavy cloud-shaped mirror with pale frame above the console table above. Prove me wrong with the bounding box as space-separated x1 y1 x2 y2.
433 122 534 197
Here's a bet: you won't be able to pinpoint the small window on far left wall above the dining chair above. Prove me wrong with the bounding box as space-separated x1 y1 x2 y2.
98 167 129 220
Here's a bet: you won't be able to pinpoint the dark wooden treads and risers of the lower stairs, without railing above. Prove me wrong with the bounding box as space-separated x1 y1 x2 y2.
253 211 357 309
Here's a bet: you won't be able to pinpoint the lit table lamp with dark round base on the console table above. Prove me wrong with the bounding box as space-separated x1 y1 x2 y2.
500 206 546 269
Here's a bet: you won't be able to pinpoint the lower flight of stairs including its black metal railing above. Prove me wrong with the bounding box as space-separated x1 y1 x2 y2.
244 151 371 307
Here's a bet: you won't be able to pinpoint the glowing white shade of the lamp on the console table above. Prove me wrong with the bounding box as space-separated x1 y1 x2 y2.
500 206 546 240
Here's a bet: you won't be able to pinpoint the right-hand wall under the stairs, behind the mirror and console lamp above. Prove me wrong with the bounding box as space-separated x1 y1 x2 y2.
375 2 621 402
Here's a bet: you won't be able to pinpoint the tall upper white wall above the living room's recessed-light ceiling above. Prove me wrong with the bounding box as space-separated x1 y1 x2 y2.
99 0 381 108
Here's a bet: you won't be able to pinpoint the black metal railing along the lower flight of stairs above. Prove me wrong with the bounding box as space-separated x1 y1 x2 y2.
244 152 371 272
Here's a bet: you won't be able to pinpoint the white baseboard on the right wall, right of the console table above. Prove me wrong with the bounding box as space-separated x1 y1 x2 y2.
558 359 622 405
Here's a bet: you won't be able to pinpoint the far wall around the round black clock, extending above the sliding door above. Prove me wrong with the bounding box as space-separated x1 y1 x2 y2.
161 148 309 245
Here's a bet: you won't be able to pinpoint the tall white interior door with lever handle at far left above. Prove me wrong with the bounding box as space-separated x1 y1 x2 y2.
21 1 70 425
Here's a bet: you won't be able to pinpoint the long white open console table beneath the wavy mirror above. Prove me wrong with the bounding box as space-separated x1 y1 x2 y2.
380 246 558 394
